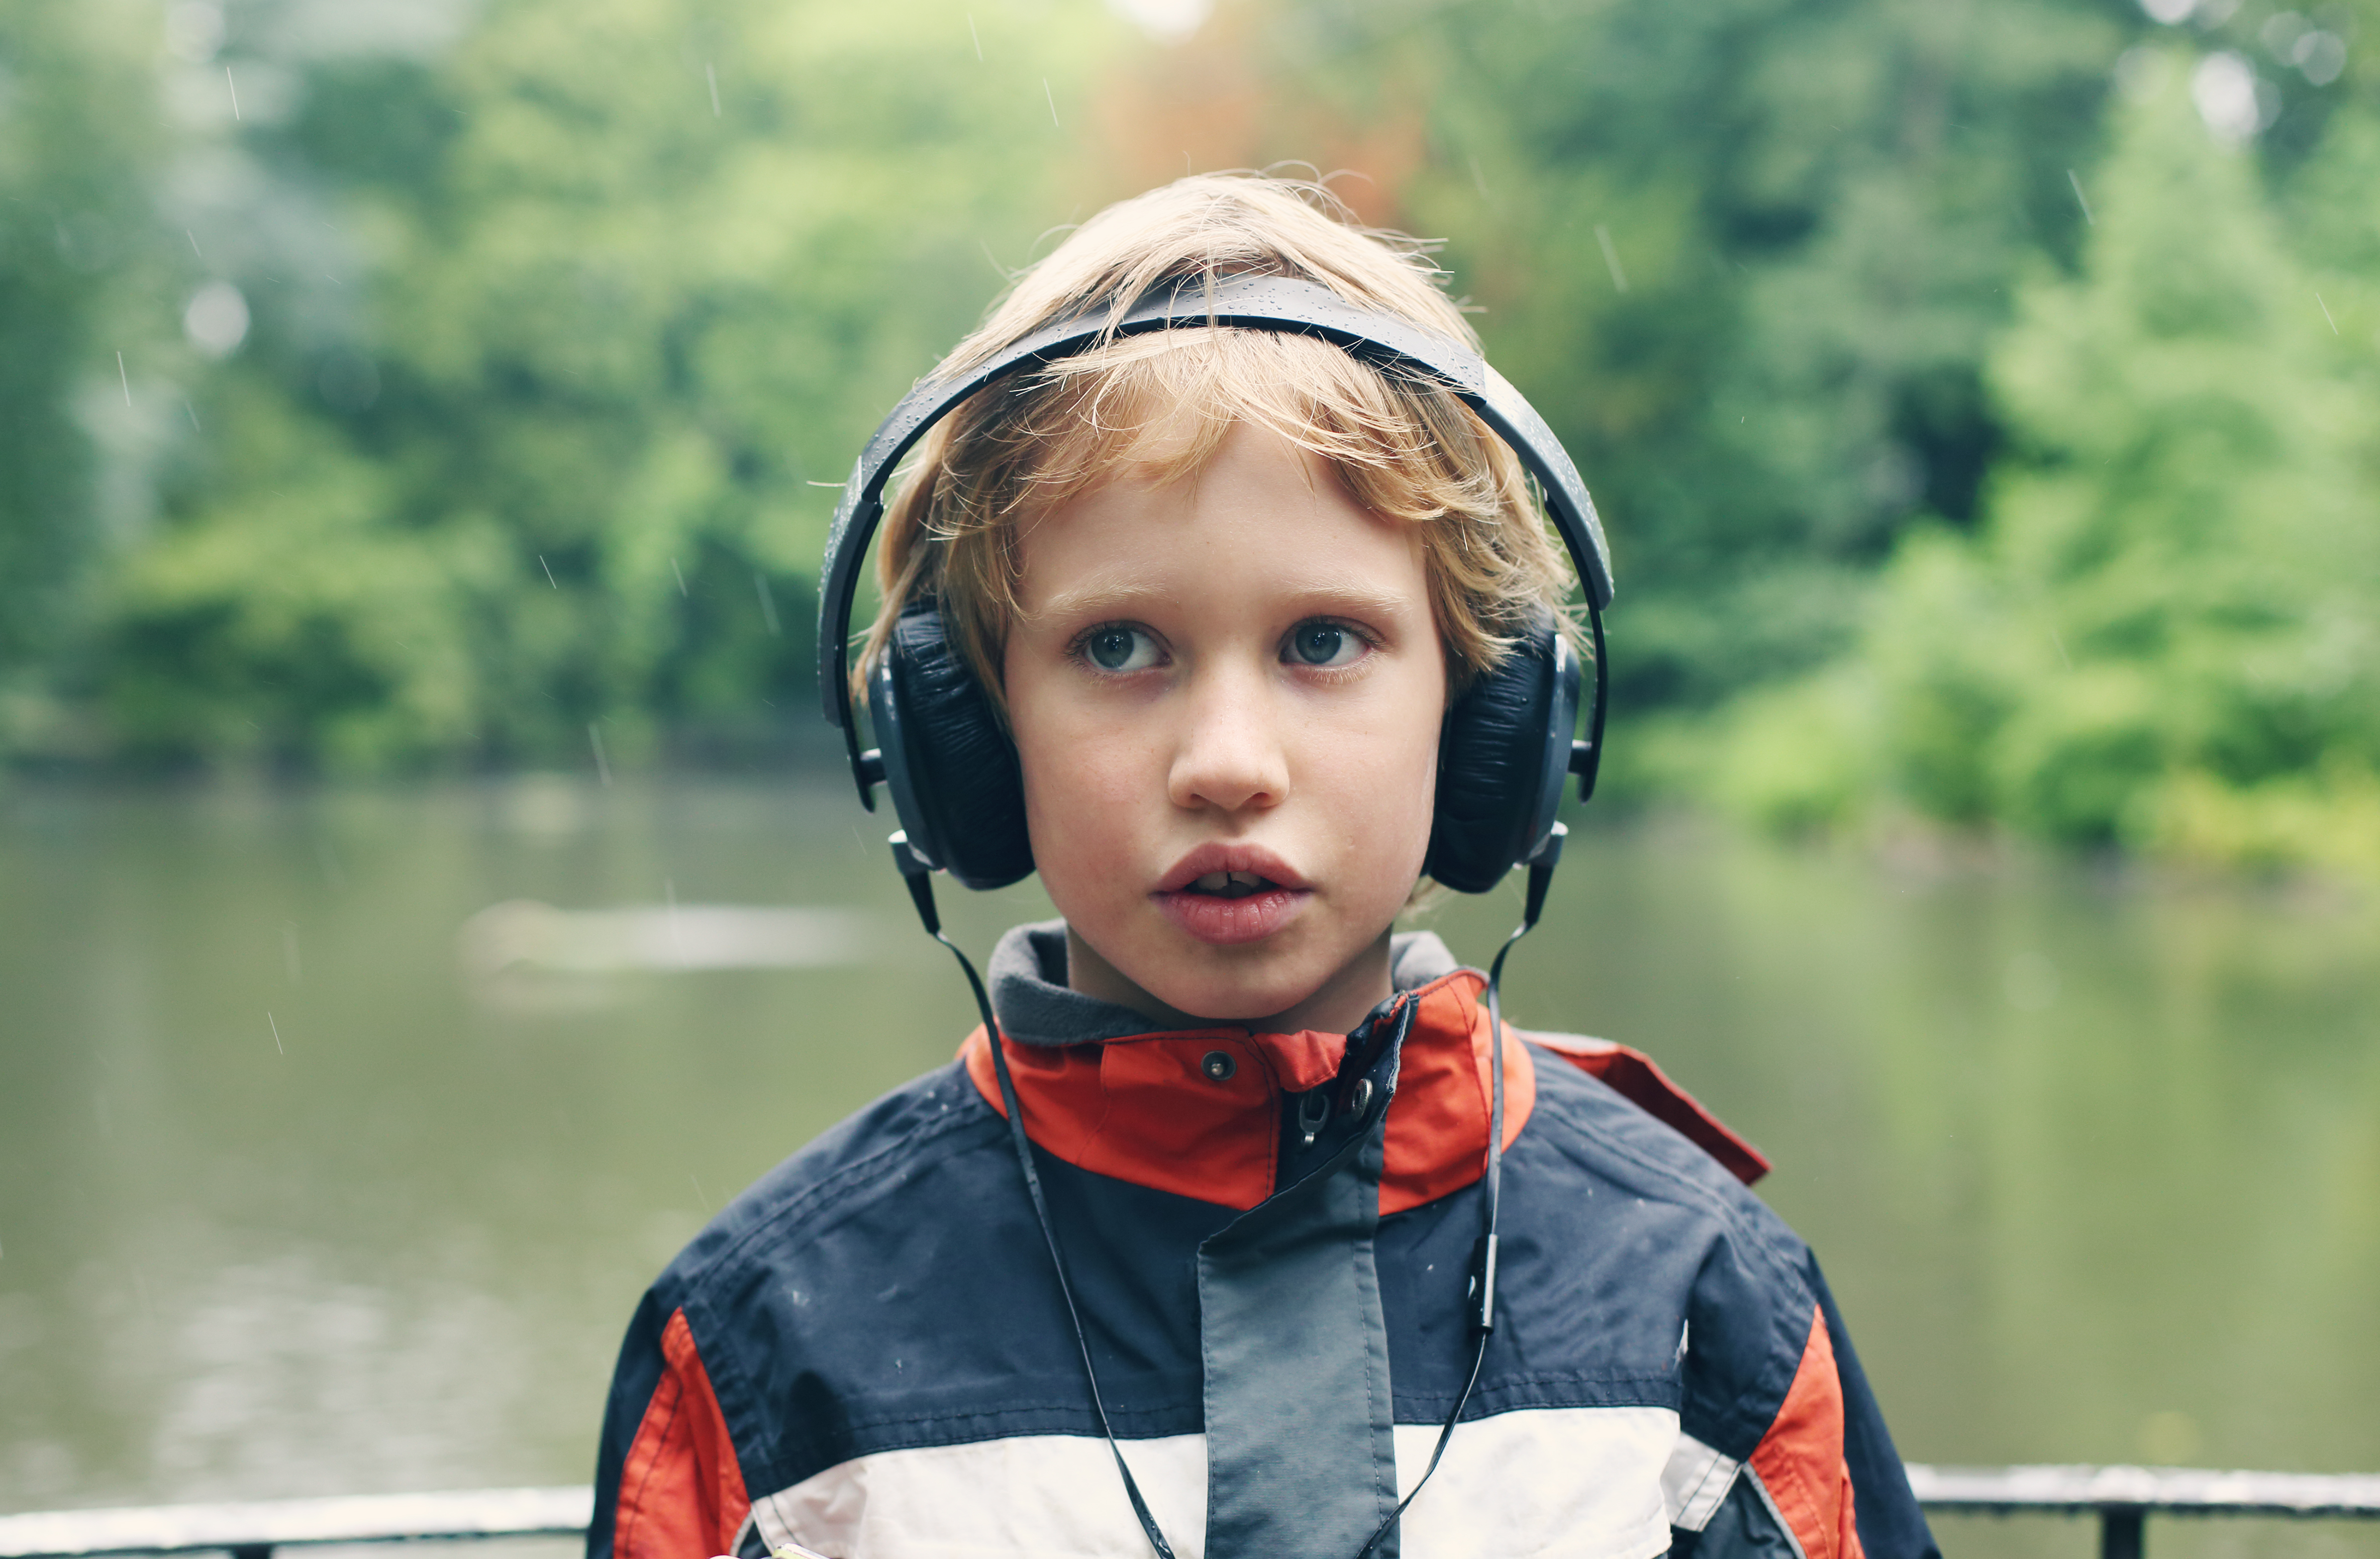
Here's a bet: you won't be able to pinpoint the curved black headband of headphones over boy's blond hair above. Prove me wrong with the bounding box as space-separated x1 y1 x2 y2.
819 276 1611 809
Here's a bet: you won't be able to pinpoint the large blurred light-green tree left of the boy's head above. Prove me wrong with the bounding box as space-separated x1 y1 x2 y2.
105 0 1109 769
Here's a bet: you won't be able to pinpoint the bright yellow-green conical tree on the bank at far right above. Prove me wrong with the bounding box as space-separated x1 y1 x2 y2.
1740 55 2380 866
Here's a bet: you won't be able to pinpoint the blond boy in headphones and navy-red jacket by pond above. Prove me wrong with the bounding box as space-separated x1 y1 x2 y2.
588 176 1933 1559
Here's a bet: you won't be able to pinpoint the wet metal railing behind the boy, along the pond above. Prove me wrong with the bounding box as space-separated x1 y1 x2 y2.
0 1466 2380 1559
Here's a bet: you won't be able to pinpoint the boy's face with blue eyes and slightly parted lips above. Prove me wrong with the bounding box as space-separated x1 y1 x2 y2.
1005 424 1447 1031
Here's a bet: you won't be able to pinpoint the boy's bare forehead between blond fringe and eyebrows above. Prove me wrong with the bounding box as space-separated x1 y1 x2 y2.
1016 424 1428 617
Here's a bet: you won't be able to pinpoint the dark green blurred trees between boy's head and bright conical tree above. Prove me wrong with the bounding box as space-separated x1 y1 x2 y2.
1361 0 2140 712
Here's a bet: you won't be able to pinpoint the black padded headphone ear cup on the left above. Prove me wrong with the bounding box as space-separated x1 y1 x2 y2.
869 602 1033 888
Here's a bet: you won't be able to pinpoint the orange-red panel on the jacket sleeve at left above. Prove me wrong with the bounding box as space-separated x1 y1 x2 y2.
612 1309 752 1559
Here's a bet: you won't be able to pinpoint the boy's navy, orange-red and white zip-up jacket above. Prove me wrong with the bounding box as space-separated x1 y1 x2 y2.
588 924 1935 1559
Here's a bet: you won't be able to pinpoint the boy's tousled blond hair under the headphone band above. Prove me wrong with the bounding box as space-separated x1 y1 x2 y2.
854 174 1575 714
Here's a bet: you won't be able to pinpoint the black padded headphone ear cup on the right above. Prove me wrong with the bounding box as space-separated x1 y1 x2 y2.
1423 624 1578 893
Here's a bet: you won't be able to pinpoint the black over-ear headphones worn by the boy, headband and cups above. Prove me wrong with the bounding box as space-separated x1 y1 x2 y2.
819 276 1611 893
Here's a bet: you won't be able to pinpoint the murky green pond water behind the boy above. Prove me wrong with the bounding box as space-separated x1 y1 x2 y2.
0 778 2380 1554
